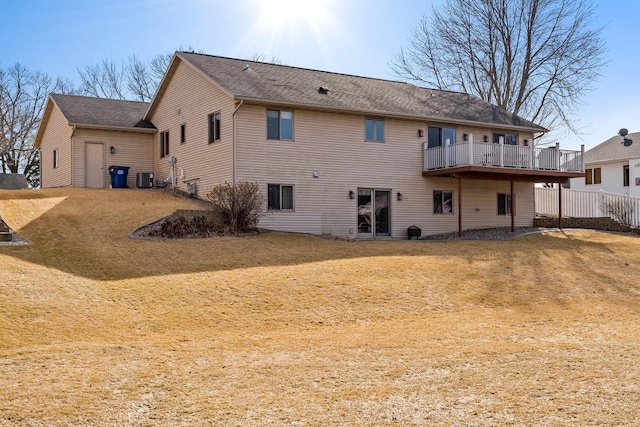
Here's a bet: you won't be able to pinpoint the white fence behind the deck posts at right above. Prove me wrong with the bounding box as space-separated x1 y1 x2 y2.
535 187 640 227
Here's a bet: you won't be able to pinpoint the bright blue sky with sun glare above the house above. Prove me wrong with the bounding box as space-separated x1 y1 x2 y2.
0 0 640 149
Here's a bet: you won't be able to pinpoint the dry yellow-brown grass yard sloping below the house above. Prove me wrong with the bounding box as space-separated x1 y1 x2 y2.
0 189 640 426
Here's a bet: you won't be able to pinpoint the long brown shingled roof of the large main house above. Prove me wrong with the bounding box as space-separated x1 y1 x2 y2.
145 52 546 132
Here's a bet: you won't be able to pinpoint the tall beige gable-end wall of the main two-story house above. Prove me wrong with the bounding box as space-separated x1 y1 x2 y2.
146 63 234 196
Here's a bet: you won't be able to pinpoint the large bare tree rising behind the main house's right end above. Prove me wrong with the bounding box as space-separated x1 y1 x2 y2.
390 0 605 144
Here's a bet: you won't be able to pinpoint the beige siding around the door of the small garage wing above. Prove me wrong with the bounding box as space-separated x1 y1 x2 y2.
73 129 155 188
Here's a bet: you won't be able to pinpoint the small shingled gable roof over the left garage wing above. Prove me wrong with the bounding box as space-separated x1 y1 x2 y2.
35 93 156 147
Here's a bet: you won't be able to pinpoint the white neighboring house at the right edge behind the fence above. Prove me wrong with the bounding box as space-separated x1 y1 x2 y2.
570 132 640 198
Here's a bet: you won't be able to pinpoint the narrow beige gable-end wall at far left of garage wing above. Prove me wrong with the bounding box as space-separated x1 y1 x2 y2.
40 105 73 188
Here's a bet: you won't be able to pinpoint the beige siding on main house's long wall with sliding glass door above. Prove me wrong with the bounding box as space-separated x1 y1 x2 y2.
237 105 533 238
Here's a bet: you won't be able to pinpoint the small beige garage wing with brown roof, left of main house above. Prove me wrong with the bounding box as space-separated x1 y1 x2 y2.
35 94 157 188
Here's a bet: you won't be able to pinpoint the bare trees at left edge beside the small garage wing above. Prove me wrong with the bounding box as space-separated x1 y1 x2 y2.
0 64 60 186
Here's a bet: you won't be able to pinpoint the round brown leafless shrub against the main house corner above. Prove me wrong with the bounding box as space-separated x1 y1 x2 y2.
206 182 264 233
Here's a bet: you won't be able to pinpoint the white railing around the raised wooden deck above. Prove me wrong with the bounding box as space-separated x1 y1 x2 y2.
423 134 584 172
